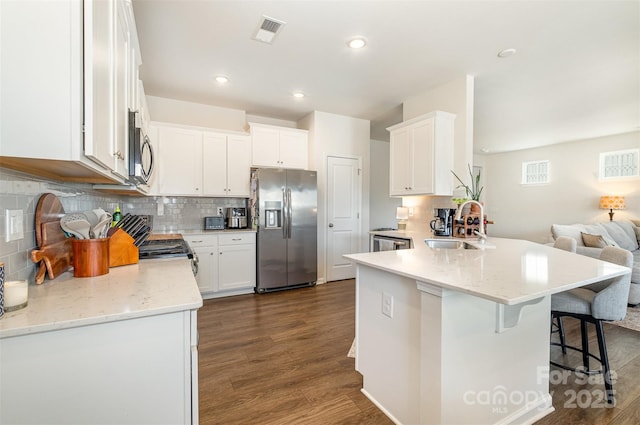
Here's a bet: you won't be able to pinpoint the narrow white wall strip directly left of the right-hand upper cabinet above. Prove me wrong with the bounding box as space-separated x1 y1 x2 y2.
369 139 402 229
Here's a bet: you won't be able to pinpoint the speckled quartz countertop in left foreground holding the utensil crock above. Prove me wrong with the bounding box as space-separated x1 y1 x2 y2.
0 258 202 338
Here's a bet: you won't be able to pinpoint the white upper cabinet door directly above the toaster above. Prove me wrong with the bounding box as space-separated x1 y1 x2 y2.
202 133 229 196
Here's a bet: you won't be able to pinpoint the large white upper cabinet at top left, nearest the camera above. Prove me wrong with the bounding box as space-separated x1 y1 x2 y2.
0 0 140 183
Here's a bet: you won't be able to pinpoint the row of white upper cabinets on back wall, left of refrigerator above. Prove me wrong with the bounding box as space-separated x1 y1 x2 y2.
152 121 251 198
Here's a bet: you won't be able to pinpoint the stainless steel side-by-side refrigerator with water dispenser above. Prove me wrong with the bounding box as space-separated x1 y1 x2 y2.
249 168 318 293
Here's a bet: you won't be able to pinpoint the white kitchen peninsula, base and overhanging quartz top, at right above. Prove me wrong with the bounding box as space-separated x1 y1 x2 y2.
346 237 630 424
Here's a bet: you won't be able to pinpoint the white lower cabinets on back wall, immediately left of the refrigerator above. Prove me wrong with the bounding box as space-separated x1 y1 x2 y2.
183 231 256 298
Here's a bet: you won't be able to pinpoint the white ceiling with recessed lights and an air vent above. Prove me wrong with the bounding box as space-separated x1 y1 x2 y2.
133 0 640 153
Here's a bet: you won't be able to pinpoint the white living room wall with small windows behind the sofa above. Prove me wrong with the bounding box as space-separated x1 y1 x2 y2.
482 132 640 242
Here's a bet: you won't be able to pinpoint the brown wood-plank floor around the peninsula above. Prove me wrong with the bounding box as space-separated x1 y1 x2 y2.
198 280 640 425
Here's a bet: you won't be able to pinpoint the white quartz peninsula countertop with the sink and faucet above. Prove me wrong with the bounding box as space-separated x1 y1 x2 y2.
345 235 631 305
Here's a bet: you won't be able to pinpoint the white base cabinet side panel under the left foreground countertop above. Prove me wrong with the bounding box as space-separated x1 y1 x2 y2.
0 310 198 424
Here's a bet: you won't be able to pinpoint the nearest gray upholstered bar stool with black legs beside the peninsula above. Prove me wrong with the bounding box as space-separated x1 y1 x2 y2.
551 246 633 404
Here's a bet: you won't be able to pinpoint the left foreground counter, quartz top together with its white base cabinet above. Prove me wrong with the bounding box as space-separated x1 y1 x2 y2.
0 258 202 424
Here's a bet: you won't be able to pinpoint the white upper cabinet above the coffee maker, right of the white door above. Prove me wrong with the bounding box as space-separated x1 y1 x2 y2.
387 111 455 196
